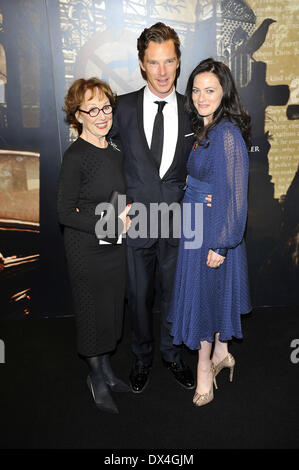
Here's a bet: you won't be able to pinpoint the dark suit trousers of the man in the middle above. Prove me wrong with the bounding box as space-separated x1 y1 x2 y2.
127 239 180 366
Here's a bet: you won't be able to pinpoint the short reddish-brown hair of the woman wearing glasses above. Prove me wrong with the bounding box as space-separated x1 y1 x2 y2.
63 77 117 134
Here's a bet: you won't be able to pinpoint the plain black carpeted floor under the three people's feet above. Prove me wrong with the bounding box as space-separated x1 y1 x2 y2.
0 307 299 450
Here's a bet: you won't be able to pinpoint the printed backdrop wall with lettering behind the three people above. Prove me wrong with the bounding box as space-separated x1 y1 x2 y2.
0 0 299 316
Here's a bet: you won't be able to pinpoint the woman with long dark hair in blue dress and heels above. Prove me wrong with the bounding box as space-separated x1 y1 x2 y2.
168 59 251 406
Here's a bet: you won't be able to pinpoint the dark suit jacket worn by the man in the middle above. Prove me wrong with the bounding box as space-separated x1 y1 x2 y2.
114 88 194 247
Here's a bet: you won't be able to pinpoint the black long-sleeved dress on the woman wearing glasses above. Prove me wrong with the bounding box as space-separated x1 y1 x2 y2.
57 137 126 356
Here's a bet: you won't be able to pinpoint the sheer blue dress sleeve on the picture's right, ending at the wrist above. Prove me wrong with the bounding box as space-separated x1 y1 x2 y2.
211 122 249 250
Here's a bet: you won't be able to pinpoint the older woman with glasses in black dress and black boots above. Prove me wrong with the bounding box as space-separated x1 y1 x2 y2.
58 78 130 413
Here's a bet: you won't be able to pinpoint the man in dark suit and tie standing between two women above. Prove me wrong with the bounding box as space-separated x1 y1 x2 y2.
114 23 194 393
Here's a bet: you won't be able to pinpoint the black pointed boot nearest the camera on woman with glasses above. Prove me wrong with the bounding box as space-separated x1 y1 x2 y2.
85 356 118 413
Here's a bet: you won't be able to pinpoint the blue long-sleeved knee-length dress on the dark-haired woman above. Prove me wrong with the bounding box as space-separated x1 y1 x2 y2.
168 119 251 349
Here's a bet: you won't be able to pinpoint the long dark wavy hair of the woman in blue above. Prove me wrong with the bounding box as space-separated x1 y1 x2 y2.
185 58 250 147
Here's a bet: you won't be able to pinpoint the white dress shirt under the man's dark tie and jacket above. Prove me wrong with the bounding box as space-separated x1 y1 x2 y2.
143 85 178 178
